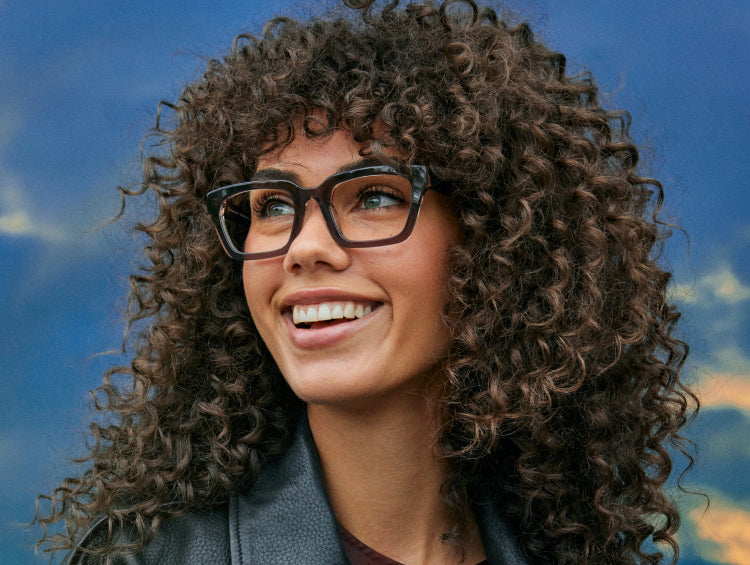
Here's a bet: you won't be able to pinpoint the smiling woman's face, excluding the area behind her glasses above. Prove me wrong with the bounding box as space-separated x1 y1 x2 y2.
243 131 458 404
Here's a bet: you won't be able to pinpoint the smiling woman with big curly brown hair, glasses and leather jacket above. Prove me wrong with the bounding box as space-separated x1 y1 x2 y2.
39 0 697 565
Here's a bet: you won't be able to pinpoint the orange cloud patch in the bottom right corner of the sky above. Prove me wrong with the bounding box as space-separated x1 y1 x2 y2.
689 499 750 565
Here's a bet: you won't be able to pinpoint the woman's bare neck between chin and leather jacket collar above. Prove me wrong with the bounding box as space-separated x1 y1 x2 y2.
308 393 481 564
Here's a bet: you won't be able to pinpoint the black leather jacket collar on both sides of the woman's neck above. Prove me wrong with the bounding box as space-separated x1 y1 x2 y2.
229 410 527 565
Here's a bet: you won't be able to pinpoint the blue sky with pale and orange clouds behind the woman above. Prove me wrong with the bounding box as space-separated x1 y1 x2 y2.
0 0 750 565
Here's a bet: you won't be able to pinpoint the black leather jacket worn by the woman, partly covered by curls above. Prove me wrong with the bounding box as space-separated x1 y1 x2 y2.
62 419 527 565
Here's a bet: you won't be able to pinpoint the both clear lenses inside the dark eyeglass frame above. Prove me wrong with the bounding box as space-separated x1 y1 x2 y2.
224 174 412 253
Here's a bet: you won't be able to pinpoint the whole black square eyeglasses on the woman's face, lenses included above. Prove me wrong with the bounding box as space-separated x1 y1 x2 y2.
206 165 444 261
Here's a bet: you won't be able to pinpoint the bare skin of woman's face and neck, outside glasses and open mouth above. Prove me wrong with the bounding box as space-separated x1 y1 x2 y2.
243 131 484 564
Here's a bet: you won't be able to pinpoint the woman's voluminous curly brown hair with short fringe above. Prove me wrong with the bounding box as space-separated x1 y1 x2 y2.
37 0 698 564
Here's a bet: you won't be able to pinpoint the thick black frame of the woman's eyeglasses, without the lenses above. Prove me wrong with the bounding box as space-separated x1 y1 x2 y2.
206 165 445 261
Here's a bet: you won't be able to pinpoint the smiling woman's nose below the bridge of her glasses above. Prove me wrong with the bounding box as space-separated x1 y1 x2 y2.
284 198 350 273
